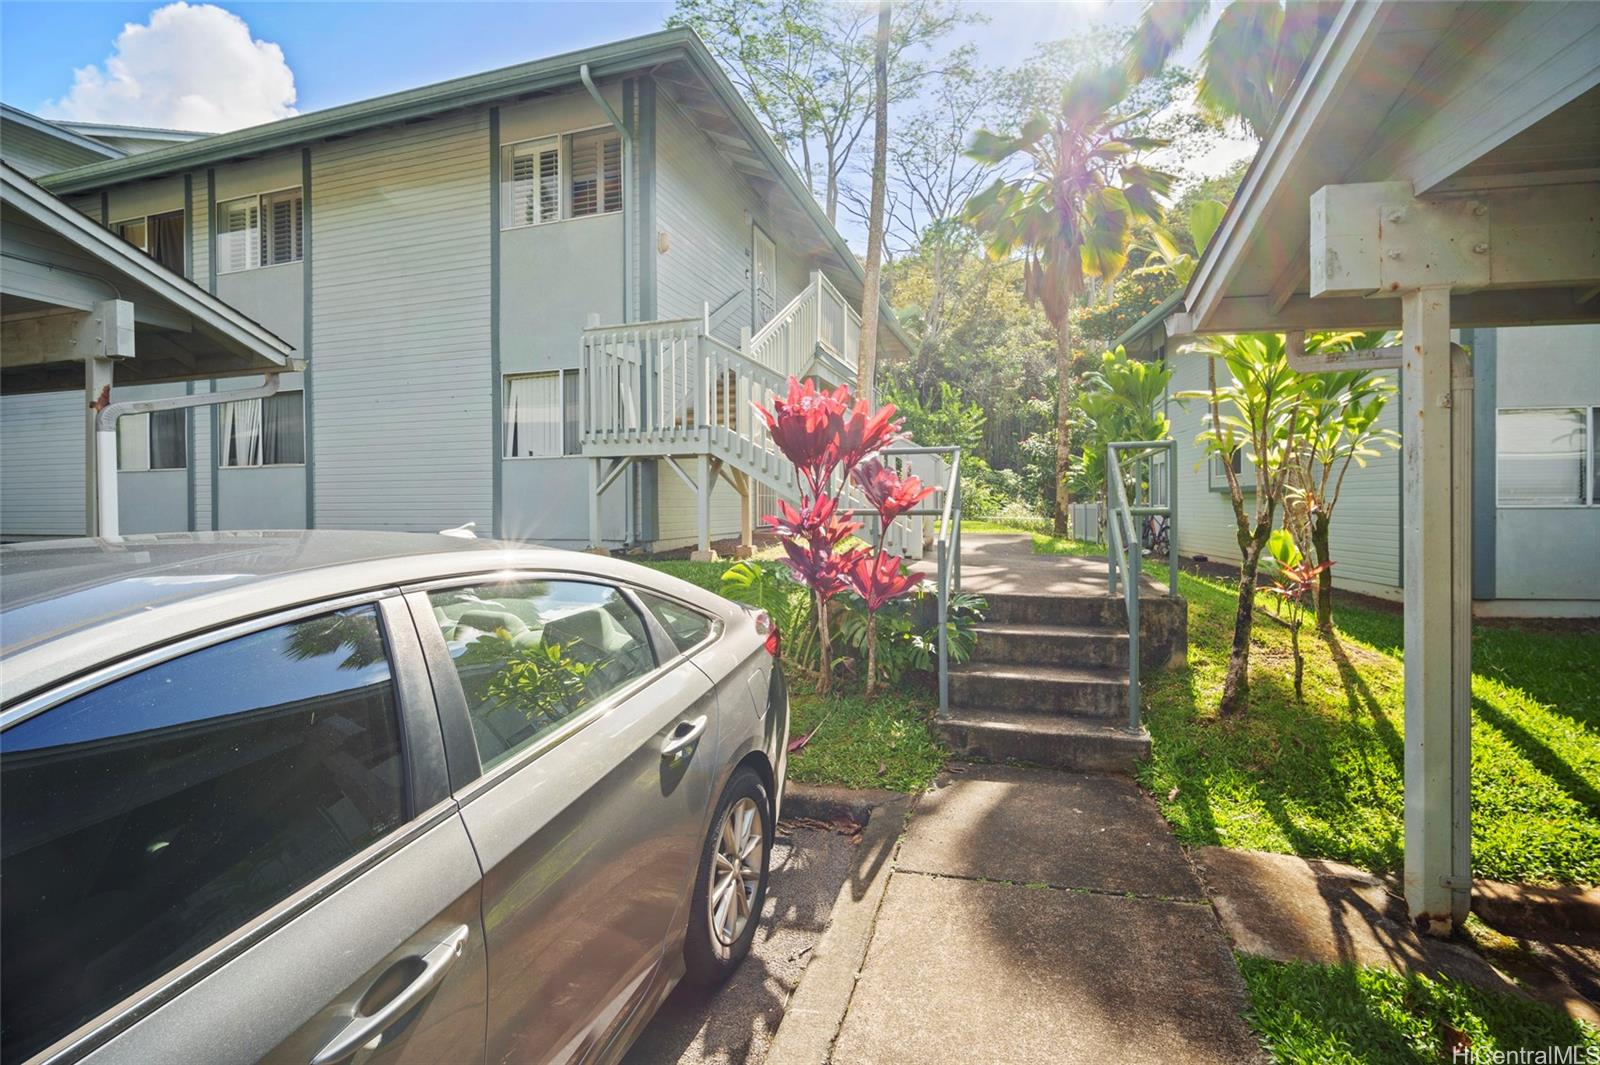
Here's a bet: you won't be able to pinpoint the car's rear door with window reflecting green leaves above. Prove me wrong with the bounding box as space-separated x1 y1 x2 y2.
408 576 718 1062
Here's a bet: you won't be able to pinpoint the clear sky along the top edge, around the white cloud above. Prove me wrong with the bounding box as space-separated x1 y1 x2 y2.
0 0 1141 119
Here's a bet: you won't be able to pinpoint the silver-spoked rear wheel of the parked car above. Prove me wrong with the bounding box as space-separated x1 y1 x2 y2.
683 768 773 987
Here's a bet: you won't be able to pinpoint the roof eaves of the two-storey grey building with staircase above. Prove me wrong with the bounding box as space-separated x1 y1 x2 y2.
42 27 912 350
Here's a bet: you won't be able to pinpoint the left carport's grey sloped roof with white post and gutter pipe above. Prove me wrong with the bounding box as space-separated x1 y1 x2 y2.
0 163 298 536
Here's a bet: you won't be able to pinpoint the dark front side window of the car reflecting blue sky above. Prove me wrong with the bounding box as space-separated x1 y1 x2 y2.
0 606 403 1060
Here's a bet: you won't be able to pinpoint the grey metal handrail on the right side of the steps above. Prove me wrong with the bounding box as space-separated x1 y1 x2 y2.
1106 438 1178 732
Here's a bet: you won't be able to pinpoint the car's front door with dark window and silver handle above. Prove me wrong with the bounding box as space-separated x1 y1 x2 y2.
0 592 486 1065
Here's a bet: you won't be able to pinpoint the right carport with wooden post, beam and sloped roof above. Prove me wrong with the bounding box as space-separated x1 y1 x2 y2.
1168 0 1600 932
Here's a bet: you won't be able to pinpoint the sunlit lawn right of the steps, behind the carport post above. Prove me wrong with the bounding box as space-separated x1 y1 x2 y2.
985 527 1600 884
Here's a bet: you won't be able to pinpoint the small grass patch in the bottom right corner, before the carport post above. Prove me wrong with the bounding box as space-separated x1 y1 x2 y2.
1237 955 1600 1065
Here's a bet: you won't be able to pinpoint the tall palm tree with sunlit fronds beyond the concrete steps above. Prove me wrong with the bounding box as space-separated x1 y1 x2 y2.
966 69 1173 536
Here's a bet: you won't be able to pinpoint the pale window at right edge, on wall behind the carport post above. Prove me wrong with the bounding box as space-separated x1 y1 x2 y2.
1494 406 1592 507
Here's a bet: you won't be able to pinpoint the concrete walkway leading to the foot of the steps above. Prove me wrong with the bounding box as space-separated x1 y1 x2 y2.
832 766 1261 1065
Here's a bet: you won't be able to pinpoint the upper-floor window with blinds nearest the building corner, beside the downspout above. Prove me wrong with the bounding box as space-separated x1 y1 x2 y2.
501 130 622 229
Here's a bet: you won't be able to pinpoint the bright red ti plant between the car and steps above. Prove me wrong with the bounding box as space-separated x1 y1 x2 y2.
755 377 933 694
